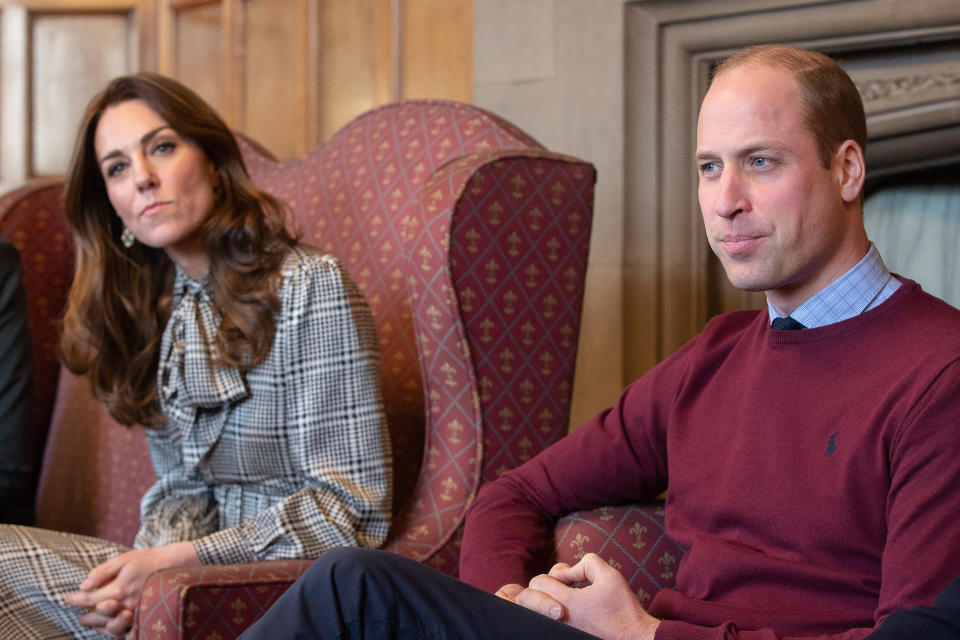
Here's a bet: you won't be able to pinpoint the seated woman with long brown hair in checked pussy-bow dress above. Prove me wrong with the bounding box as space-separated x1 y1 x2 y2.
0 73 391 638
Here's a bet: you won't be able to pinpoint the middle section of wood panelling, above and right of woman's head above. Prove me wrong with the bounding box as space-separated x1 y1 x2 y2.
157 0 320 158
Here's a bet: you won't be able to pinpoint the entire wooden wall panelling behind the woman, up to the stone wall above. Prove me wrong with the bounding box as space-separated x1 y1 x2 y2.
0 0 473 193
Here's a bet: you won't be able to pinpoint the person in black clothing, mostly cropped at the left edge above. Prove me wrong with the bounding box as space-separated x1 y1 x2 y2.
0 238 36 524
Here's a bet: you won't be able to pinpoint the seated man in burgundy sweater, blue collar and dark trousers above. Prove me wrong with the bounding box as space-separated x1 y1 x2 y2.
238 47 960 640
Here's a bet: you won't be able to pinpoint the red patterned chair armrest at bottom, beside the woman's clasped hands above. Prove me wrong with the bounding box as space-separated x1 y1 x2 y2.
134 560 313 640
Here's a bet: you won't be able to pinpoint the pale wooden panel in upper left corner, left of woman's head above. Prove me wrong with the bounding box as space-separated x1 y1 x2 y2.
0 0 154 192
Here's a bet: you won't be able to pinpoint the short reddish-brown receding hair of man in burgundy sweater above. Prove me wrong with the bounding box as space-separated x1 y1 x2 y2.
713 44 867 168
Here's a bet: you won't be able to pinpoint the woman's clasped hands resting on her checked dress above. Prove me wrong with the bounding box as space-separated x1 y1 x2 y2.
64 542 199 638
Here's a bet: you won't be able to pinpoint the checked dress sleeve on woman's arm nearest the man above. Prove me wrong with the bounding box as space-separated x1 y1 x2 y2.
194 256 392 563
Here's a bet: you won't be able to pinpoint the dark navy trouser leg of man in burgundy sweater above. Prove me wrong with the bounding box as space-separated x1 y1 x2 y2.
240 548 596 640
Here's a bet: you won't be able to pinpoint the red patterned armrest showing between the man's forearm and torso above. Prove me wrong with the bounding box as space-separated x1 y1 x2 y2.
554 502 686 608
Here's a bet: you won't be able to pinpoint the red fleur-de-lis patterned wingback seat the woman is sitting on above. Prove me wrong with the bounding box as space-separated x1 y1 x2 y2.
0 101 595 639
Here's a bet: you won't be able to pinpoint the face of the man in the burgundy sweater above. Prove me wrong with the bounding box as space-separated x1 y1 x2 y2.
697 64 867 313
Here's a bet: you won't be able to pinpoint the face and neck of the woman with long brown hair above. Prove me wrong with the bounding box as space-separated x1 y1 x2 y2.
94 100 217 279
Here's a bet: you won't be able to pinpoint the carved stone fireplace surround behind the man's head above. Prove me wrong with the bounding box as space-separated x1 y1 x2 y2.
624 0 960 379
